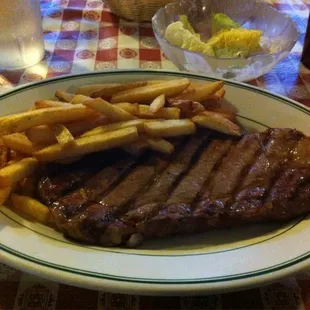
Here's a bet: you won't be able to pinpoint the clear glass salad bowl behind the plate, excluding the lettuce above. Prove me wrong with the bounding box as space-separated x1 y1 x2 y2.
152 0 298 81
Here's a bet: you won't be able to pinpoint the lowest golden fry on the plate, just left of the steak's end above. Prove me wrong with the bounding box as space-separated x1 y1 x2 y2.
11 194 50 224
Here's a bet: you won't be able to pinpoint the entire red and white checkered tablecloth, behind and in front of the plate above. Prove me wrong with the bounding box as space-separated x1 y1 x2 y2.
0 0 310 310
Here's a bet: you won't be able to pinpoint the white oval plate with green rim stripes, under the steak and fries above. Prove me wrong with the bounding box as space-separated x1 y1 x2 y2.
0 70 310 295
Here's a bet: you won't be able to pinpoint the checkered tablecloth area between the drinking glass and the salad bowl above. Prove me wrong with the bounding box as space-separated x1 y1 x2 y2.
0 0 177 92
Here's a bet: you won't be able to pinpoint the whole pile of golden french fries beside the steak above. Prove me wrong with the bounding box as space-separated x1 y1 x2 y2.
0 78 241 224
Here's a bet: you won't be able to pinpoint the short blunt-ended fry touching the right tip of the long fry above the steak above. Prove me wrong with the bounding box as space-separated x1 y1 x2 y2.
144 119 196 137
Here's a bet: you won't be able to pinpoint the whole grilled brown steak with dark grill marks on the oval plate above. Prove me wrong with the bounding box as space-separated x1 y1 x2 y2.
38 129 310 246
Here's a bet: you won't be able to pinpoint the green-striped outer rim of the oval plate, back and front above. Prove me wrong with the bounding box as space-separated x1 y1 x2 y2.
0 69 310 294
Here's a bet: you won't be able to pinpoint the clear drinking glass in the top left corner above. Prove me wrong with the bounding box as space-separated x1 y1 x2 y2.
0 0 44 70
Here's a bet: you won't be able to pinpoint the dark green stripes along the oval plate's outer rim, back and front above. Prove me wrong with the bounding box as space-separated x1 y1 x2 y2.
0 70 310 285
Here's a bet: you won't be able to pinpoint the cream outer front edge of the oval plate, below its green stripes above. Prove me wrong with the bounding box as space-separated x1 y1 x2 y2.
0 241 310 296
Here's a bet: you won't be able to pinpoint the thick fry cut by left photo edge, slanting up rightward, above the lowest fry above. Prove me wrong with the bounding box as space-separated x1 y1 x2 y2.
0 157 38 187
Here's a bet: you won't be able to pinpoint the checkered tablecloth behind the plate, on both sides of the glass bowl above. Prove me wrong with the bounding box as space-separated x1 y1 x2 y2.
0 0 310 106
